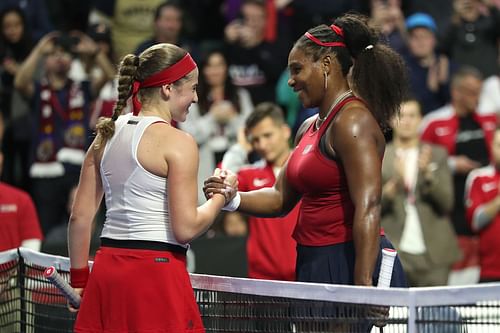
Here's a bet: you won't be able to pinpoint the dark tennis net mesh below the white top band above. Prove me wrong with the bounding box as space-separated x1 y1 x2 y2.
0 249 500 333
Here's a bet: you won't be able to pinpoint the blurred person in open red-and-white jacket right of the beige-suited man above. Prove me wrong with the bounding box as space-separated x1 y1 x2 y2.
421 67 497 284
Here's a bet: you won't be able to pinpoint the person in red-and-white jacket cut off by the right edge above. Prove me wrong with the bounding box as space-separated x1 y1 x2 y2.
465 127 500 282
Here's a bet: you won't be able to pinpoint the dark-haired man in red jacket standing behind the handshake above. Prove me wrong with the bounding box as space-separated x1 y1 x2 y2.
222 102 299 281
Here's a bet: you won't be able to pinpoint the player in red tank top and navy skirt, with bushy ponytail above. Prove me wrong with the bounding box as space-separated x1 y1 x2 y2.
204 14 407 294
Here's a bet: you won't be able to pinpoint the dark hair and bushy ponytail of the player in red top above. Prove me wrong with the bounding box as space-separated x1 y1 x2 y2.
295 13 408 129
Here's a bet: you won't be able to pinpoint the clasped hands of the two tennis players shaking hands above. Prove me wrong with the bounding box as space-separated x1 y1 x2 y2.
203 168 241 211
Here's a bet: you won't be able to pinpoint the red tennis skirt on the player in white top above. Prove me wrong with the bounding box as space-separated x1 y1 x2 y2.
74 247 205 333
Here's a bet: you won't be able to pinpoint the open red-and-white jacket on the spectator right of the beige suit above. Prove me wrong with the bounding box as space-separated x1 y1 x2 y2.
421 105 497 156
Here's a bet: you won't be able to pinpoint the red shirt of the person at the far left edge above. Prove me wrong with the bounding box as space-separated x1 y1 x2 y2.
0 183 43 251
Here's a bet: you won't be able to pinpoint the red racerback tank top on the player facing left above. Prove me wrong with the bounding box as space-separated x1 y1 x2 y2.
286 97 382 246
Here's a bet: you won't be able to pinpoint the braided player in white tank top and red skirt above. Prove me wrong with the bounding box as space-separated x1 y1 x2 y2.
68 44 236 333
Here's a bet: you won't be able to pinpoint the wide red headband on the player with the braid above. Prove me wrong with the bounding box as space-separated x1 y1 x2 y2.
132 53 196 116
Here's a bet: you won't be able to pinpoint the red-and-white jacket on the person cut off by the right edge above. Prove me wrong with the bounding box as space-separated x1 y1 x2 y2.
465 165 500 279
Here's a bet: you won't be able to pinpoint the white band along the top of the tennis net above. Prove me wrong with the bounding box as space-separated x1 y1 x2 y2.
0 248 500 307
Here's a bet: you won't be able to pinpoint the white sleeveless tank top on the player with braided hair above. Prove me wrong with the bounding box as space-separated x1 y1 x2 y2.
100 113 184 246
